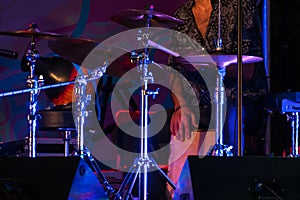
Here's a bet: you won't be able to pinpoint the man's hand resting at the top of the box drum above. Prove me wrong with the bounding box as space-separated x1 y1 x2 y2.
170 106 198 141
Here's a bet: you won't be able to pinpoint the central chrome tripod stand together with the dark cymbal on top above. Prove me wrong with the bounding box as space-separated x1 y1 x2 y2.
111 6 176 200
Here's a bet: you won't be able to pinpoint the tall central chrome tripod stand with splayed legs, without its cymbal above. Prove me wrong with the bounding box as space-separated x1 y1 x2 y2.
118 6 176 200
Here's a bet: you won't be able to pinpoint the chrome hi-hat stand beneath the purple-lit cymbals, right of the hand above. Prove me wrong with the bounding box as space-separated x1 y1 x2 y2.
207 67 233 156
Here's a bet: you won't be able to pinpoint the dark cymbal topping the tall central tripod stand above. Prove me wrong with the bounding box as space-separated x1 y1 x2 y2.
111 9 184 28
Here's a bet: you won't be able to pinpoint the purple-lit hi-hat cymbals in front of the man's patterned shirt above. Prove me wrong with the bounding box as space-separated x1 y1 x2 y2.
185 54 263 68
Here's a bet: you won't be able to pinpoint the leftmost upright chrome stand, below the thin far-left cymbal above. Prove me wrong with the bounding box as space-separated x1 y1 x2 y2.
26 37 44 158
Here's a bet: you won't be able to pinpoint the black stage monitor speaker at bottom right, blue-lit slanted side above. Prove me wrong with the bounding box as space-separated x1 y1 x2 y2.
174 156 300 200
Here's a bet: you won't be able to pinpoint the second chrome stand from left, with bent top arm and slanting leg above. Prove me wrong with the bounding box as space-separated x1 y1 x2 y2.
74 66 122 199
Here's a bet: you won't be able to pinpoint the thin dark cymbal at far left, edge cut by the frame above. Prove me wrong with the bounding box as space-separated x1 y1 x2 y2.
0 23 64 39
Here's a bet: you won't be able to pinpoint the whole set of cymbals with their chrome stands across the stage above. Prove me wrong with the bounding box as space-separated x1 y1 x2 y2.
0 6 261 199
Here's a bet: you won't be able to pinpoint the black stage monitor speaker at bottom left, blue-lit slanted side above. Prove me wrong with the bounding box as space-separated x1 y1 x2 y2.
0 157 108 200
